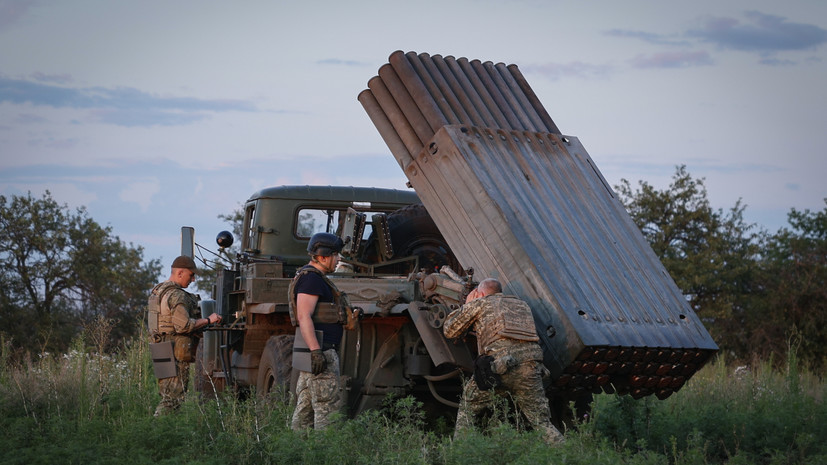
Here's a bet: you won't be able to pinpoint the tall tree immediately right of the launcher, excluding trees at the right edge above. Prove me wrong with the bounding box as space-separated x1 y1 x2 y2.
615 165 759 353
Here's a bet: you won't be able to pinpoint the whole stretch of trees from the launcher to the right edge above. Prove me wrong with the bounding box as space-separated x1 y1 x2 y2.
615 166 827 373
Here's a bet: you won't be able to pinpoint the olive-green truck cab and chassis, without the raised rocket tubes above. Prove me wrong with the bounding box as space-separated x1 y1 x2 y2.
193 186 473 415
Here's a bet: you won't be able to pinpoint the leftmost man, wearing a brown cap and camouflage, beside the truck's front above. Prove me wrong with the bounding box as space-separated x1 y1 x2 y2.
149 255 221 417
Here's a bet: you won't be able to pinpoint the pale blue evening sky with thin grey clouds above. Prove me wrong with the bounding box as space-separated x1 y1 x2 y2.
0 0 827 266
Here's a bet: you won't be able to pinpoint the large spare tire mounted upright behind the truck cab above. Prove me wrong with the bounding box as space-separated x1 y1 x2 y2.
365 204 462 274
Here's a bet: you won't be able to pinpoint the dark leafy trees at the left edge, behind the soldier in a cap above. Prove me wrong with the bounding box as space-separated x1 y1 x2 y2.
0 191 160 352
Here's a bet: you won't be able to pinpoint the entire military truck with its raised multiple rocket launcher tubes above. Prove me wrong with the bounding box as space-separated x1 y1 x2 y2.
188 51 717 420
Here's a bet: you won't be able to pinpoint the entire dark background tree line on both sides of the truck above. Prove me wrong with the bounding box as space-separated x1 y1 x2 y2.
0 166 827 372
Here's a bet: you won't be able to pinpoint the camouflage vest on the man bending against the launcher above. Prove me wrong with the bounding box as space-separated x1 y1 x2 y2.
475 294 540 353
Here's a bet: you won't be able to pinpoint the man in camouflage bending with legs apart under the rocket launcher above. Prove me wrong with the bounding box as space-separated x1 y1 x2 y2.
443 278 563 444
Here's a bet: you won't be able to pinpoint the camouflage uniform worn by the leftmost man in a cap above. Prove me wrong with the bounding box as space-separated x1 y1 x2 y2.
152 281 198 417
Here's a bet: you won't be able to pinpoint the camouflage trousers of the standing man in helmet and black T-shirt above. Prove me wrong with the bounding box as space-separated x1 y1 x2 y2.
290 349 344 431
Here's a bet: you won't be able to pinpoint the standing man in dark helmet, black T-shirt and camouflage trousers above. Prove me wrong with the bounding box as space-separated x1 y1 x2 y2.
289 233 344 431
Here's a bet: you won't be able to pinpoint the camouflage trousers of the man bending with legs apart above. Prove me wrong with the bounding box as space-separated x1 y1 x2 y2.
454 360 563 444
